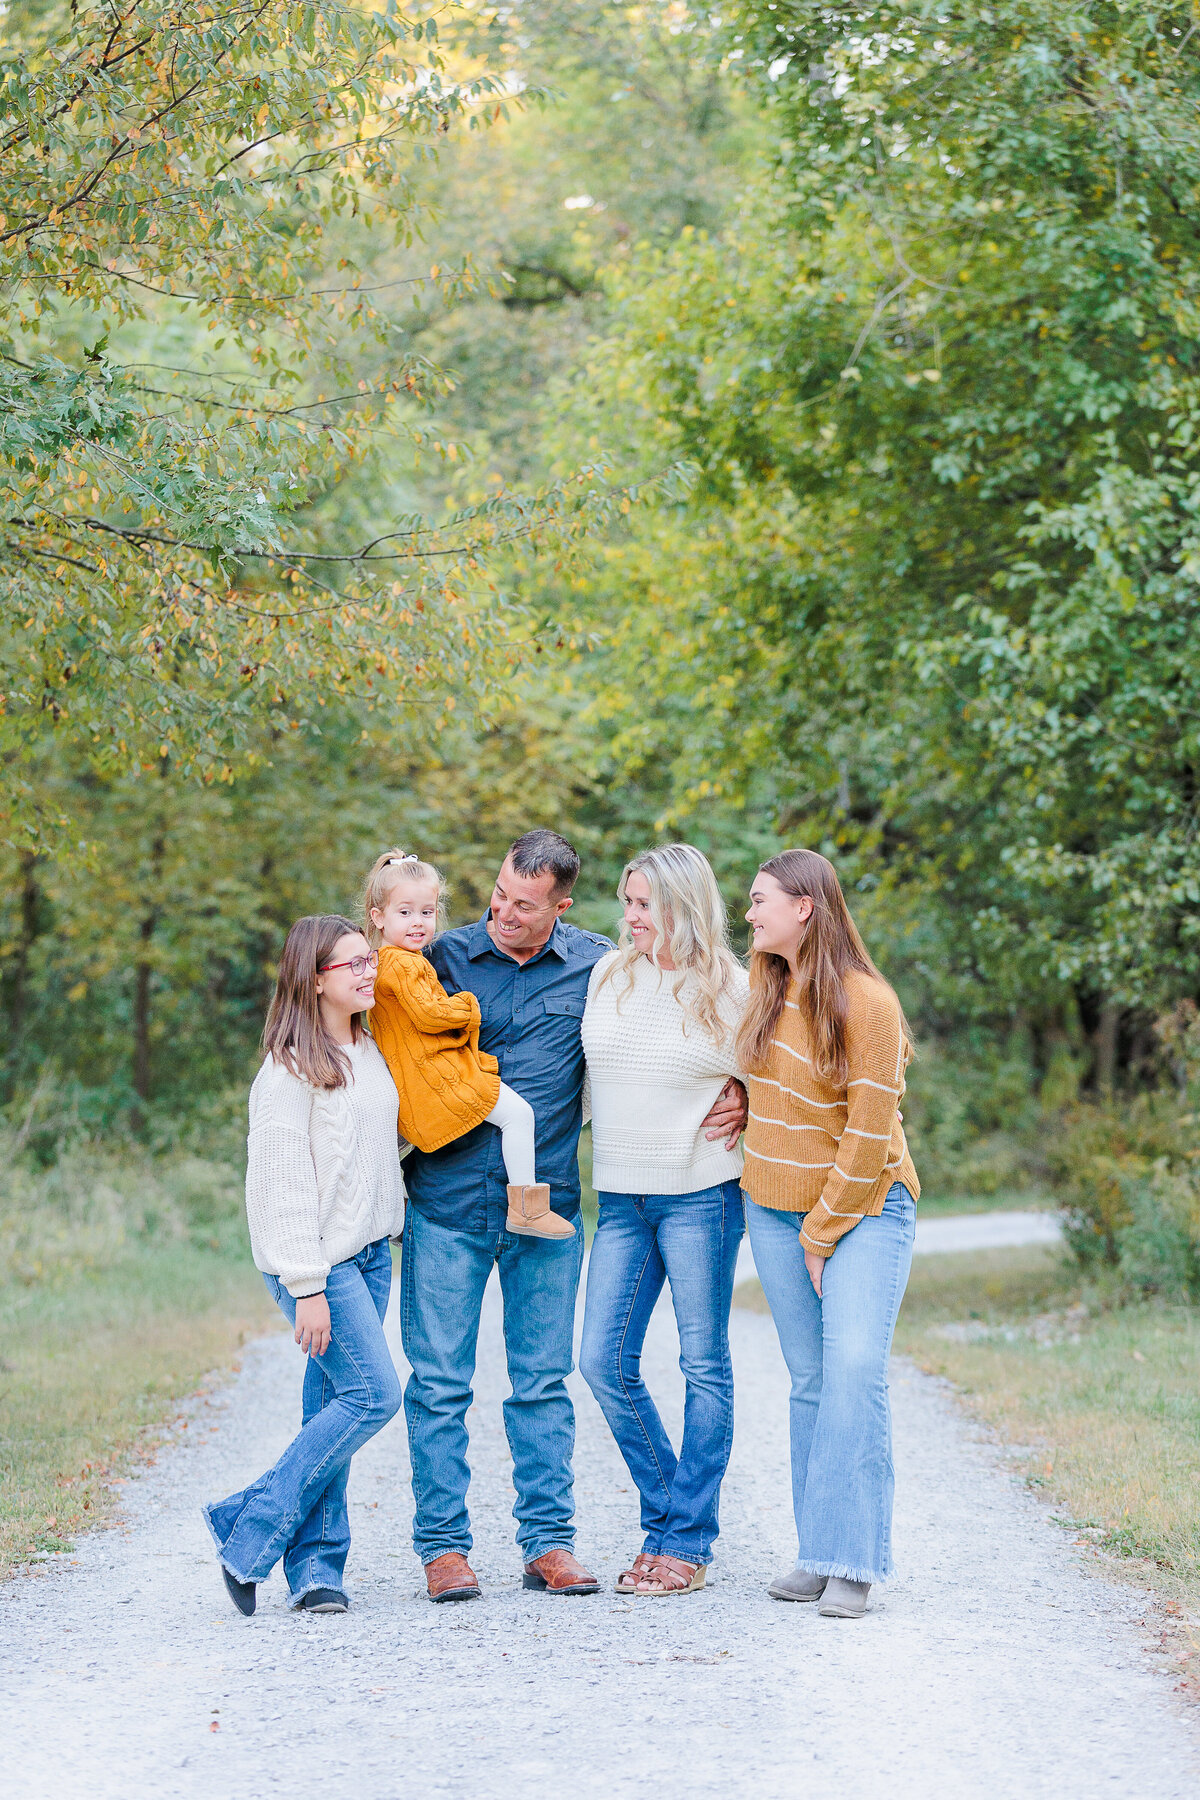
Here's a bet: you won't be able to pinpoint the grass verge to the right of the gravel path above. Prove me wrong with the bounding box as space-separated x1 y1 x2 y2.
738 1246 1200 1607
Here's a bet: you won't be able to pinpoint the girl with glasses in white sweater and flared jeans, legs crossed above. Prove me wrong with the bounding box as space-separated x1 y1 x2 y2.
205 916 405 1615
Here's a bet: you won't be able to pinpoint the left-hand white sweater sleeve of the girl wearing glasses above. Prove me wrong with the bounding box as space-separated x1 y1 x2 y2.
246 1064 329 1300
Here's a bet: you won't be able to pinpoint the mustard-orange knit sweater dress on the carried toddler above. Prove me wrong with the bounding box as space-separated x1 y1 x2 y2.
371 943 500 1150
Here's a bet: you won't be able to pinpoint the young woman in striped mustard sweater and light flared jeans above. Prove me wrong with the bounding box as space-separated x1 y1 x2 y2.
738 850 921 1618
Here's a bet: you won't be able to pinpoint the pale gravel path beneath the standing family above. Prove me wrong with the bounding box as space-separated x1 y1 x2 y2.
0 1283 1200 1800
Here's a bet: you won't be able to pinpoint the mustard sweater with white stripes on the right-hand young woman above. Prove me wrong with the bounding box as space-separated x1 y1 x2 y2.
741 970 921 1256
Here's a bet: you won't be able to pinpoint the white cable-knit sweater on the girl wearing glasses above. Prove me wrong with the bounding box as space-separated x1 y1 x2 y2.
246 1037 405 1300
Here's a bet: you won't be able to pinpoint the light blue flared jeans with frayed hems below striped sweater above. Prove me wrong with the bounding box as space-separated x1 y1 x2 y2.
747 1183 916 1582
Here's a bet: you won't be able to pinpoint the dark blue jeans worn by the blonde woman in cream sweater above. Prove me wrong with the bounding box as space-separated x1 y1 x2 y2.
579 1181 743 1562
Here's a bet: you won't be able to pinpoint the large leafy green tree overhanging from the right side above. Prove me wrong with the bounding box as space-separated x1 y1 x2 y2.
563 0 1200 1058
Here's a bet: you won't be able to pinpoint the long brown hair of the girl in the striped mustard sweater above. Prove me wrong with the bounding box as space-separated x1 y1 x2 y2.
738 850 912 1087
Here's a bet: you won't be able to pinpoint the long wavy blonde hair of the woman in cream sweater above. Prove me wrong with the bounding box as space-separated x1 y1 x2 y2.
599 844 741 1044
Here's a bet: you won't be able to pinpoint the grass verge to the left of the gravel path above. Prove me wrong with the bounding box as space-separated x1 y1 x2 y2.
0 1242 279 1575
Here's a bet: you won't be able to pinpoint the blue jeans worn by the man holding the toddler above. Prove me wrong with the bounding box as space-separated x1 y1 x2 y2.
399 1206 583 1562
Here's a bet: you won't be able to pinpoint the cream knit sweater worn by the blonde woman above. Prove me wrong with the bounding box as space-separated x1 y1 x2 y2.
583 950 750 1193
